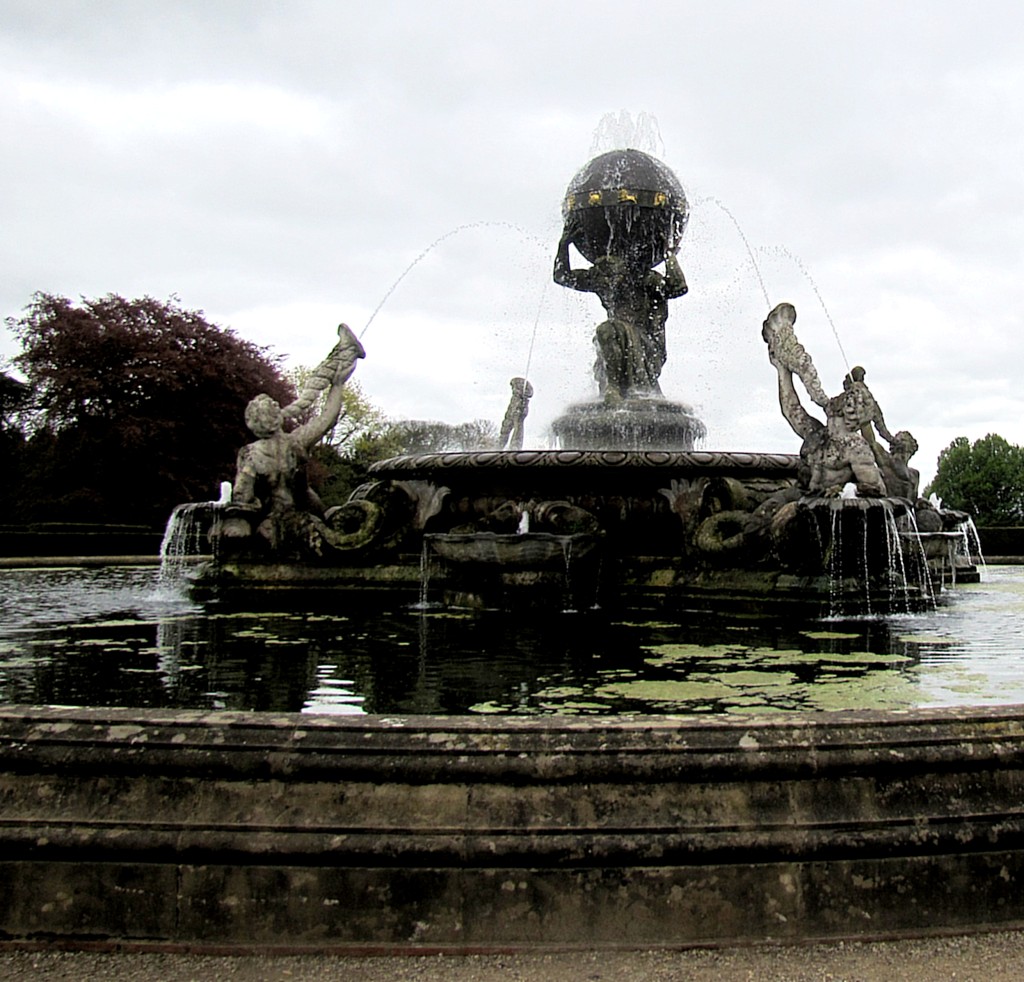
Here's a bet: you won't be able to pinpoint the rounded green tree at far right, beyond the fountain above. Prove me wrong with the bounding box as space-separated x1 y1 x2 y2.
925 433 1024 526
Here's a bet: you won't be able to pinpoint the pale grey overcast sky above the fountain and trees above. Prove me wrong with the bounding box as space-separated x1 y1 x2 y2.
0 0 1024 480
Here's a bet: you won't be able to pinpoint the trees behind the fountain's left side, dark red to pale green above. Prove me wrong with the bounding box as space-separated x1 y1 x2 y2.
0 293 497 527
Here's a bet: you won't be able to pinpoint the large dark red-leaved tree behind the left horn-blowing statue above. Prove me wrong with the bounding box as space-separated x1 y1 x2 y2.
7 293 294 525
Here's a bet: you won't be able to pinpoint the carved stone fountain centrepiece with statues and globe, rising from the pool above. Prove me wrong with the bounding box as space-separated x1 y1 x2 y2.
196 150 974 613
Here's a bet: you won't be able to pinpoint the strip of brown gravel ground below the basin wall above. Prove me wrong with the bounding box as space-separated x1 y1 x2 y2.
6 931 1024 982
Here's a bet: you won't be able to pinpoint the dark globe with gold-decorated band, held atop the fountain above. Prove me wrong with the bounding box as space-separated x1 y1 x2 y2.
562 150 689 268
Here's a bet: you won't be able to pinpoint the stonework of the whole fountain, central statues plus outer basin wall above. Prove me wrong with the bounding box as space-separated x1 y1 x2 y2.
0 144 1007 953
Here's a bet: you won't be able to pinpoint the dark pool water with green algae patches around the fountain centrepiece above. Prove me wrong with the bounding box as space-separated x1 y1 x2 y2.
0 566 1024 714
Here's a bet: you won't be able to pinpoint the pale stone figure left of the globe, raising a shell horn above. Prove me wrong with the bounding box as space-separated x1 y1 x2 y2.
222 324 366 549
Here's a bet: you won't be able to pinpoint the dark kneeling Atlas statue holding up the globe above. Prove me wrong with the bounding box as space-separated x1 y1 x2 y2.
554 212 688 402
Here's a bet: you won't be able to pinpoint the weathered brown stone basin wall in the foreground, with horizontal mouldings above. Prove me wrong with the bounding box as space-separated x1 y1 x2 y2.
0 708 1024 949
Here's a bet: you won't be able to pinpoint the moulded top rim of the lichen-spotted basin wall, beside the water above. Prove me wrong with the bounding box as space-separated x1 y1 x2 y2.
0 706 1024 783
